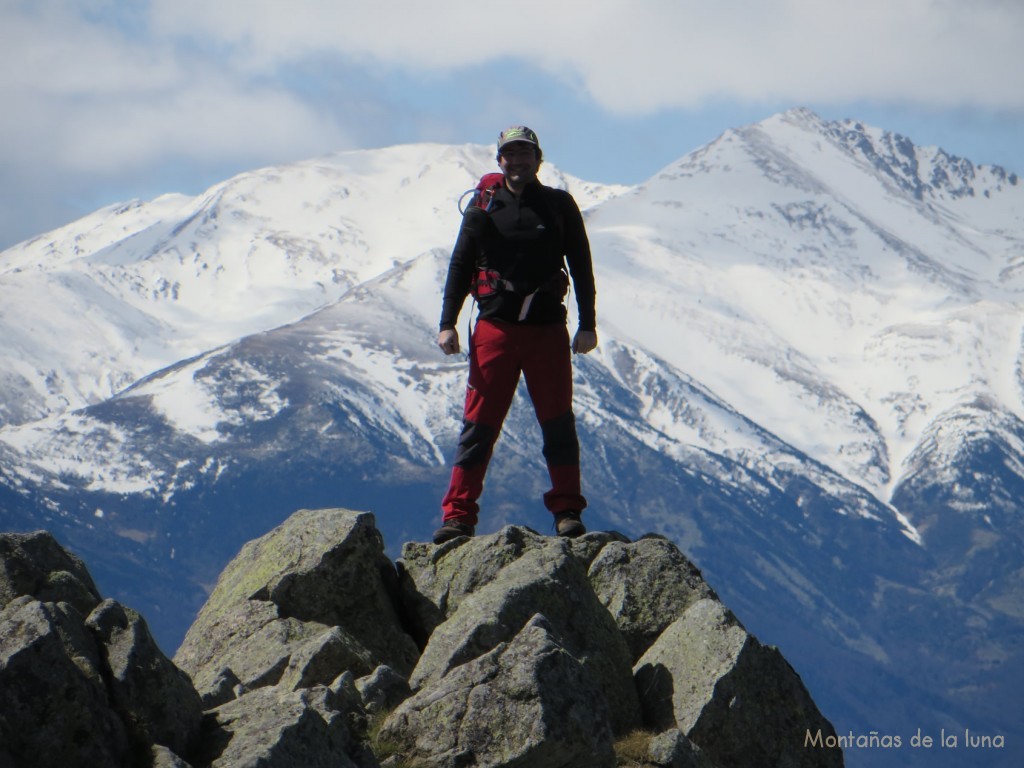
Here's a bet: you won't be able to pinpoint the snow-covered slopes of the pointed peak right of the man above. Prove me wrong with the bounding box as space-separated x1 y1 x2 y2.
592 111 1024 493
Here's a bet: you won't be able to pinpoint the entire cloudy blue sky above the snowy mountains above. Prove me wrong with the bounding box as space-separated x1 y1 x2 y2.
0 0 1024 249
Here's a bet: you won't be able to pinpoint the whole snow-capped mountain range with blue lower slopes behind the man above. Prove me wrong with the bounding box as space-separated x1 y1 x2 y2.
0 110 1024 765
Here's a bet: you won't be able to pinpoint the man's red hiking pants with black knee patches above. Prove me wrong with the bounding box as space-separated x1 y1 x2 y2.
441 321 587 525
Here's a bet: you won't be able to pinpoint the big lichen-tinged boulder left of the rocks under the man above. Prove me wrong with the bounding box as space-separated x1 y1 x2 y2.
174 510 419 702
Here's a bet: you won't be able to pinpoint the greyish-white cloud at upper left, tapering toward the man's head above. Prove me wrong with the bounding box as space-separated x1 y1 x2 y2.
0 3 344 175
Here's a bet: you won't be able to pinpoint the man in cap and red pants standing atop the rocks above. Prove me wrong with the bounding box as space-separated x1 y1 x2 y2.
433 125 597 544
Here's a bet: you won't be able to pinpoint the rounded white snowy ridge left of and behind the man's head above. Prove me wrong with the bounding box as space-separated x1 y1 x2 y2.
0 145 616 424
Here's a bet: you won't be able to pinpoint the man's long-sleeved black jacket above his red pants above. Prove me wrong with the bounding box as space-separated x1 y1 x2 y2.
440 181 597 331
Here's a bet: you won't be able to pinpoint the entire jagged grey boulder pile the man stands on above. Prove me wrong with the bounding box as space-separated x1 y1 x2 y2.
0 509 843 768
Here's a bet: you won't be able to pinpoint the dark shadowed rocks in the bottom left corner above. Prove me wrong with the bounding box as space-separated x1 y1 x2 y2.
0 532 203 768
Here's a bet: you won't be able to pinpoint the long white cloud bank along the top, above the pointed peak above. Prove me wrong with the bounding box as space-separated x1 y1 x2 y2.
144 0 1024 112
